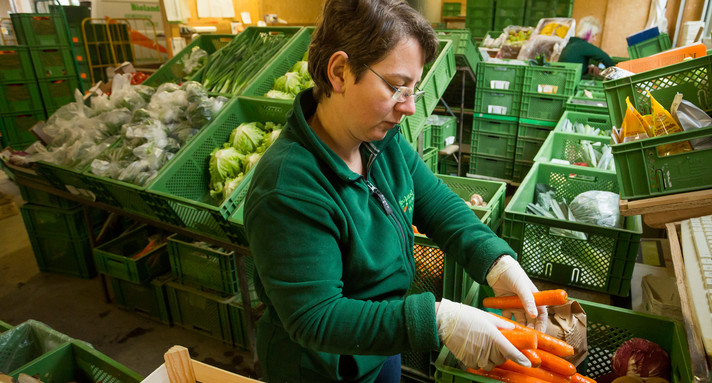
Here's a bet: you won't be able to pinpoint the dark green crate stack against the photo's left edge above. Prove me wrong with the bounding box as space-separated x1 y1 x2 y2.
0 45 45 150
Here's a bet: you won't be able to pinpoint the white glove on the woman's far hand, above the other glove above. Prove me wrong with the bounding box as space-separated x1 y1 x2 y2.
487 255 547 332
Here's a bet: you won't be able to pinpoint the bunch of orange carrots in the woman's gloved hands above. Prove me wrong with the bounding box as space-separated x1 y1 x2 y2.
467 289 595 383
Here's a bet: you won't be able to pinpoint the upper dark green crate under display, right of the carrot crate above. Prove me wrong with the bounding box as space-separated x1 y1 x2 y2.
168 234 242 295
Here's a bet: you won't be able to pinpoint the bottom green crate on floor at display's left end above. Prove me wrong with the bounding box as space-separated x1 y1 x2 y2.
27 230 96 279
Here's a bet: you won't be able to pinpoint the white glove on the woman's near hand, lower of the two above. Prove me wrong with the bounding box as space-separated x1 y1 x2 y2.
437 299 531 371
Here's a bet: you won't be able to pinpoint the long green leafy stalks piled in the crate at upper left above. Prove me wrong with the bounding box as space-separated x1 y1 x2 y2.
200 32 289 94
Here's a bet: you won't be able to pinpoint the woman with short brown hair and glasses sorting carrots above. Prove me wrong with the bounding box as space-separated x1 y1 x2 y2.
245 0 546 382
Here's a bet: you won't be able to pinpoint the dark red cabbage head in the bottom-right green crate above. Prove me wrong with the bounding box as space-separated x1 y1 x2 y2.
611 338 670 379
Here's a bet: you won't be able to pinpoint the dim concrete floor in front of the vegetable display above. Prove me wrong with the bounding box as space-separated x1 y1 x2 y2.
0 171 256 378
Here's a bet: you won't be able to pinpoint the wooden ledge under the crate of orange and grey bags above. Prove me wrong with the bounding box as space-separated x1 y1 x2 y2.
619 189 712 229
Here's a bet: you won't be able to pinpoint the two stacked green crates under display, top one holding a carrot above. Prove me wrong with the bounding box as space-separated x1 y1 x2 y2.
93 225 171 324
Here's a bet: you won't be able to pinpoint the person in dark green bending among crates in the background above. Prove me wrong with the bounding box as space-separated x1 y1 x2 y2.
559 16 615 76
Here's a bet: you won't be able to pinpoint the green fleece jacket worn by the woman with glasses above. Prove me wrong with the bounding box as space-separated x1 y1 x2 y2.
244 89 514 383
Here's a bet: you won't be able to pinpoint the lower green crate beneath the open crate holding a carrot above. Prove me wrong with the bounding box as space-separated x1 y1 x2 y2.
109 275 171 325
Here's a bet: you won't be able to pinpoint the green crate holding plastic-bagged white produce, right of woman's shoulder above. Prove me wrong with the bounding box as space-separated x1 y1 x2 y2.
502 162 643 296
